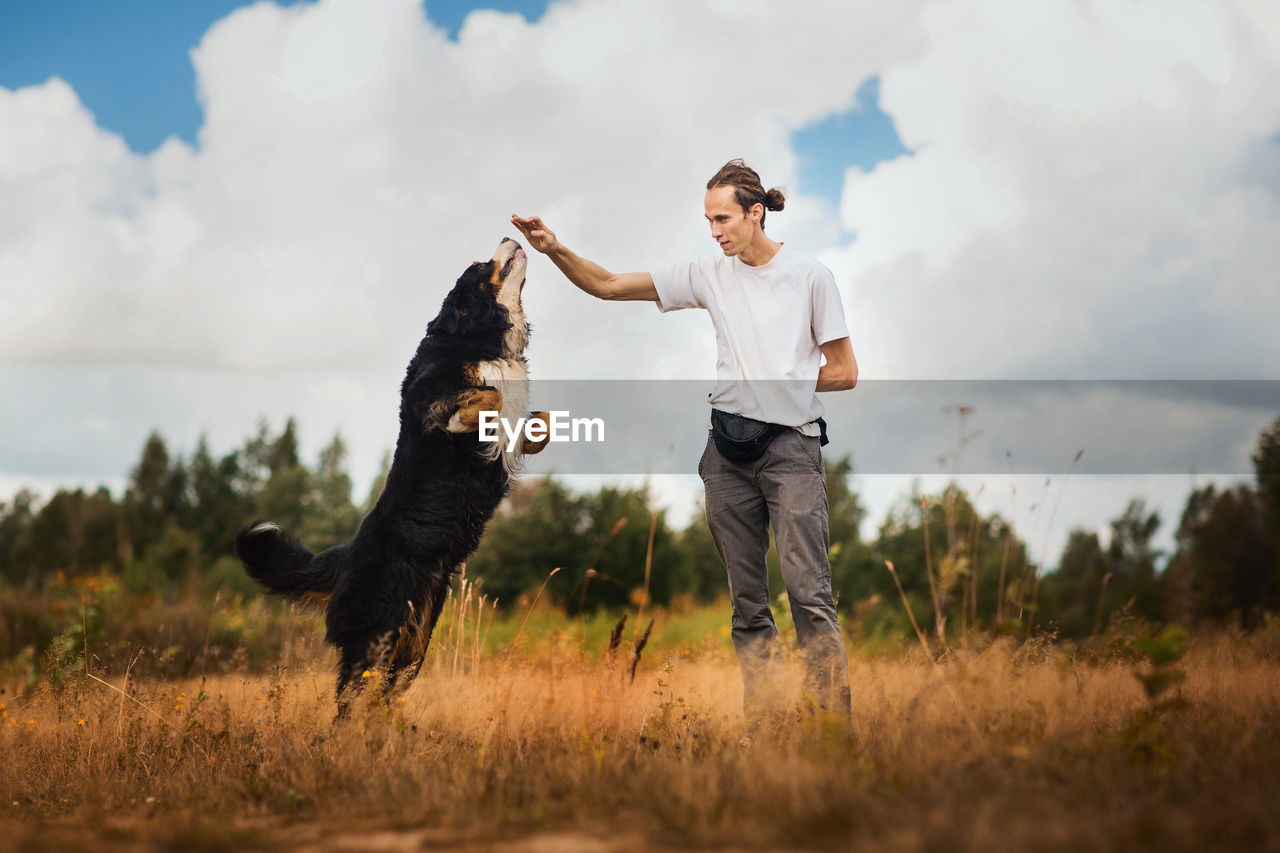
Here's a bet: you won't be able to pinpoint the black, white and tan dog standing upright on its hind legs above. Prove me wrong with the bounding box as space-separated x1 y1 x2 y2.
236 238 549 717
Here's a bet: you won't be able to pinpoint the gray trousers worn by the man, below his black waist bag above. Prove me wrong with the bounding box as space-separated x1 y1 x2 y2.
698 429 850 719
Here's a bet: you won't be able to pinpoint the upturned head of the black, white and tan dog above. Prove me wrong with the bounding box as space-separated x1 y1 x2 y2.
426 237 529 357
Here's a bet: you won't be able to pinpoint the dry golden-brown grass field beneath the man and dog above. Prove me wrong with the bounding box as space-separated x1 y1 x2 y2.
0 601 1280 850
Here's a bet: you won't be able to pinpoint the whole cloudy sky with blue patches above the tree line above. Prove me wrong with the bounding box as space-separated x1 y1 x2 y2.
0 0 1280 571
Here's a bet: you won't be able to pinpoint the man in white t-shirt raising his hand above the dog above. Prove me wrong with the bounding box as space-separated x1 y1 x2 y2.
511 160 858 722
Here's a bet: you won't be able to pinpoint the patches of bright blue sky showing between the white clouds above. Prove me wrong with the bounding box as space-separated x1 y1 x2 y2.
0 0 906 204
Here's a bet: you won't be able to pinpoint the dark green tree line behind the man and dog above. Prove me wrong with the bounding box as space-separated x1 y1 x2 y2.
0 419 1280 638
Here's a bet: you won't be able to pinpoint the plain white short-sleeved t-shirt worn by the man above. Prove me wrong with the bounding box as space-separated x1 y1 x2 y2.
652 245 849 435
